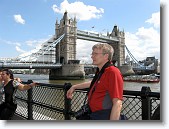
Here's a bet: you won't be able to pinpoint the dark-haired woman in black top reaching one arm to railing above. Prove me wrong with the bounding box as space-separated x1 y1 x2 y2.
0 69 36 120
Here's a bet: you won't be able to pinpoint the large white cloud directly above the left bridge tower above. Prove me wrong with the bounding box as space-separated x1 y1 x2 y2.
52 0 104 20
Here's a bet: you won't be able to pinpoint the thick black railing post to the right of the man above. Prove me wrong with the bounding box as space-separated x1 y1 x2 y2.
141 86 151 120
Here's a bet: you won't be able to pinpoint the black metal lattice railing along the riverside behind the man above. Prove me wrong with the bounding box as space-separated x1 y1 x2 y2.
16 81 160 120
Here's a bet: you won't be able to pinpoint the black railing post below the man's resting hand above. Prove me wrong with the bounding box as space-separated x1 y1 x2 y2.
64 83 71 120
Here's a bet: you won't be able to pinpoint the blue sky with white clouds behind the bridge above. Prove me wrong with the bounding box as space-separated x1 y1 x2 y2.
0 0 160 62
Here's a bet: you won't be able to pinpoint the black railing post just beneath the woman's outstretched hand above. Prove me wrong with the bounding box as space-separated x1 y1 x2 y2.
27 80 33 120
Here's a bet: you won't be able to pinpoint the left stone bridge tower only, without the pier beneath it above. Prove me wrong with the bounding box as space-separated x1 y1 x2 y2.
55 12 77 64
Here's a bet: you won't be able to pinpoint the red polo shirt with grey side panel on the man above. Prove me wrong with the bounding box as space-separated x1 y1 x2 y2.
88 66 123 112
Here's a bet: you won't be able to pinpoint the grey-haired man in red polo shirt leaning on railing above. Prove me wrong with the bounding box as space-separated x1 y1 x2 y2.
67 43 123 120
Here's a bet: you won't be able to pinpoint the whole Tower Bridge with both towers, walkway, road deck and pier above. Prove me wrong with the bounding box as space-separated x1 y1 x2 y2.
0 12 158 79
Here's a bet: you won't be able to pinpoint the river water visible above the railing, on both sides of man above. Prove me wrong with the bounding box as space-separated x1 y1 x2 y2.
14 74 160 92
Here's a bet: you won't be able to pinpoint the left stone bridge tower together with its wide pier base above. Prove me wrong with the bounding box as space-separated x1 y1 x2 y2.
49 11 85 80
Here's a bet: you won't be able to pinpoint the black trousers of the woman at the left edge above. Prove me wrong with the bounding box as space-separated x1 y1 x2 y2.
0 103 17 120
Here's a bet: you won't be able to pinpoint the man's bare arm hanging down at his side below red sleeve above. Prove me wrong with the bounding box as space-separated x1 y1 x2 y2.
110 98 122 120
